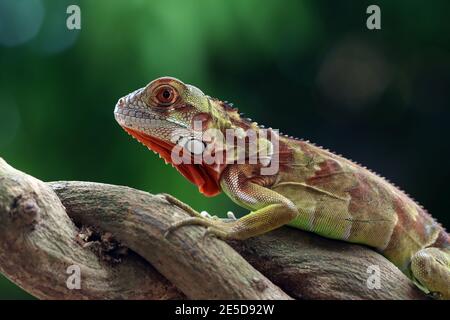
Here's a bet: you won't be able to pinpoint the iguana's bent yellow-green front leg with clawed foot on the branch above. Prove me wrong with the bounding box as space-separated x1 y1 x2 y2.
166 165 298 240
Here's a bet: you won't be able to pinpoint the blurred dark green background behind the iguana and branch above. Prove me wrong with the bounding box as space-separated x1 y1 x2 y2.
0 0 450 299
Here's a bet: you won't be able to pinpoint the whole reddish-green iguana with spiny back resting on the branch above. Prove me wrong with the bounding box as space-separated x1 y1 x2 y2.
114 77 450 299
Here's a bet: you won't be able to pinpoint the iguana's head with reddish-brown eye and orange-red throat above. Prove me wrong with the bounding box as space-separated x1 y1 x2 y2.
114 77 255 196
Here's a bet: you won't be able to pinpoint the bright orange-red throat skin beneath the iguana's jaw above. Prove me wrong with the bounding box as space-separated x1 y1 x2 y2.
123 127 223 197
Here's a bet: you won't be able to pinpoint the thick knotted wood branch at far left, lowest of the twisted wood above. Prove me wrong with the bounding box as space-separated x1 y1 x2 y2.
0 158 184 299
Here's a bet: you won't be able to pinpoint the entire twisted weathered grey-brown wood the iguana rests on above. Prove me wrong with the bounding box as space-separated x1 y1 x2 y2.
0 159 425 299
